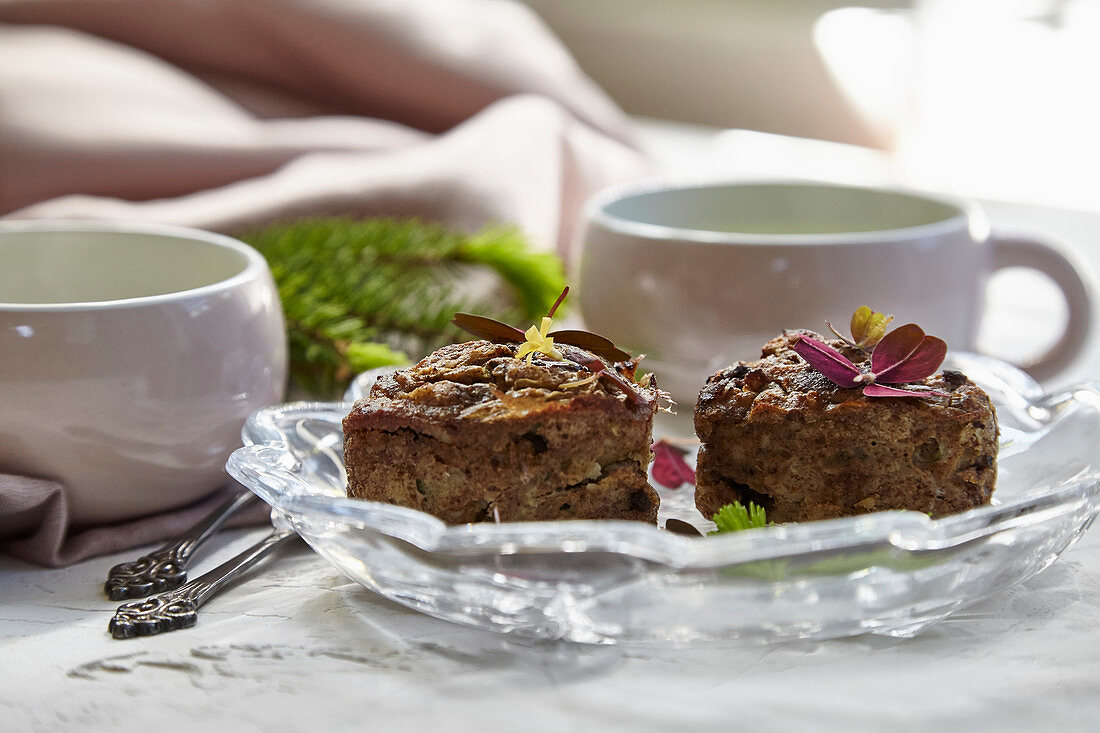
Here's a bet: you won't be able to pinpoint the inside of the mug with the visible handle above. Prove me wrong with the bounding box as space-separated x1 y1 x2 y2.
601 183 963 236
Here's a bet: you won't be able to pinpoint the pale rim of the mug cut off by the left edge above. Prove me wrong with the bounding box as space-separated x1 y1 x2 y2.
0 219 267 313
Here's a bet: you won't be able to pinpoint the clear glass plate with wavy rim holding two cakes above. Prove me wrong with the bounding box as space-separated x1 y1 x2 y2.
228 354 1100 643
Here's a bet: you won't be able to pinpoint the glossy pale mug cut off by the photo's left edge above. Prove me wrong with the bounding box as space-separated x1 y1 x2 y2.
0 222 287 528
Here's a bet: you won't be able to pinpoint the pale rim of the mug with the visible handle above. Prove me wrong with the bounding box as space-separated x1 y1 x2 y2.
585 177 989 247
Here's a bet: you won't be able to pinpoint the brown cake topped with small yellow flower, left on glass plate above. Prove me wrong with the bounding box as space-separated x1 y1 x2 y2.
343 341 658 524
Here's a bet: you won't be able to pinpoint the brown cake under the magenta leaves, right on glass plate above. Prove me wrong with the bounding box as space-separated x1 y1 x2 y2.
695 331 998 522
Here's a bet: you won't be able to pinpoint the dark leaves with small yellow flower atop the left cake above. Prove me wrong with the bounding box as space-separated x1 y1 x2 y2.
452 287 650 405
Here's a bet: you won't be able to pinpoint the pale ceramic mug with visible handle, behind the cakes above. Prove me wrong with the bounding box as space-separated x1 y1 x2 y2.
579 182 1093 412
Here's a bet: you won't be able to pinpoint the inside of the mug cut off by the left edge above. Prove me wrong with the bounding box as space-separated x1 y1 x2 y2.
0 228 249 305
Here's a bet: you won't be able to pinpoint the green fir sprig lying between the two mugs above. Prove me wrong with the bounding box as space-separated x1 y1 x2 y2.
240 218 564 397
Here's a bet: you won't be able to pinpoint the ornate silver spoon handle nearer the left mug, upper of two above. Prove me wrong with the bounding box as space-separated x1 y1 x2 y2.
103 490 259 601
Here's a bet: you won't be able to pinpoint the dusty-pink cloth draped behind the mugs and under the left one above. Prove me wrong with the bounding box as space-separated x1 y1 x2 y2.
0 0 650 565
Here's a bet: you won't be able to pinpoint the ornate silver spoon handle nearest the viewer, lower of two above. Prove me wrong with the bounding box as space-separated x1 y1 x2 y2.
107 529 298 638
